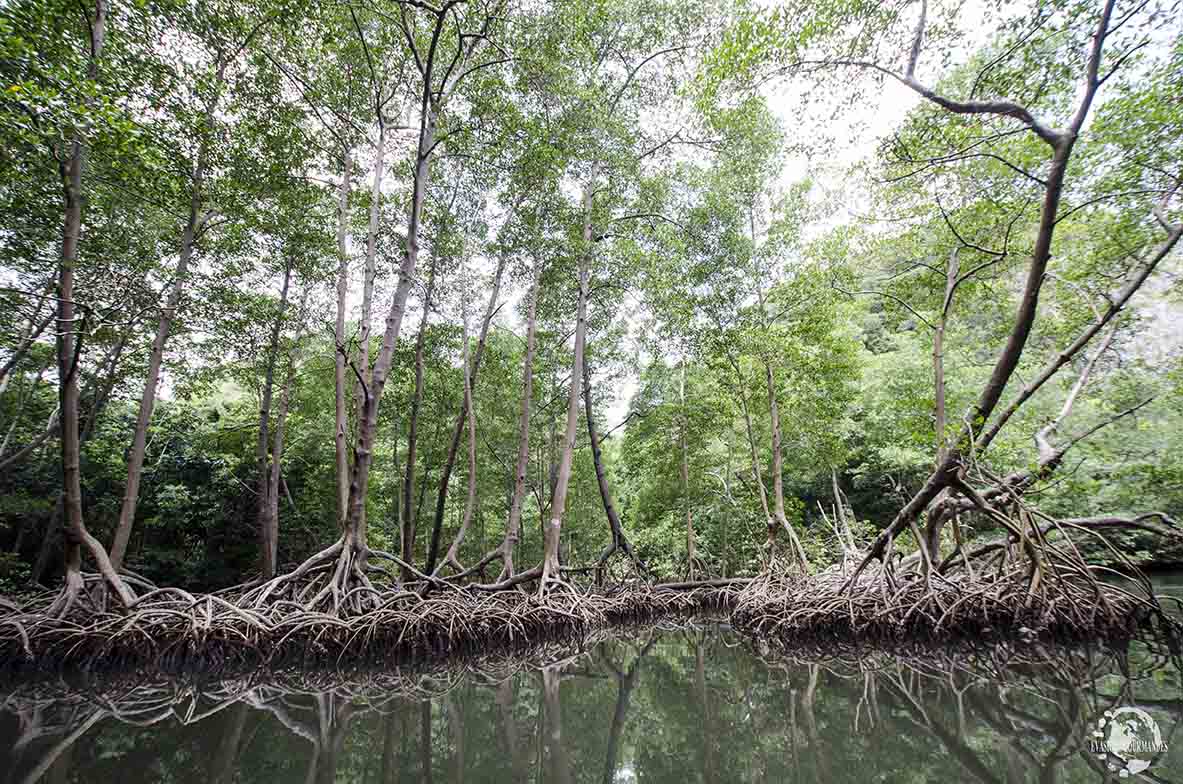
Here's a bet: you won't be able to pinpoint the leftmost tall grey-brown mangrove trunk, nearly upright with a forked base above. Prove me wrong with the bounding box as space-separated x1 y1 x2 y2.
50 0 134 615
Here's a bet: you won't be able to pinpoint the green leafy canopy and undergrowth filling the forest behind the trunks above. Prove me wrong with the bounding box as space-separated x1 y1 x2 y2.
0 0 1183 589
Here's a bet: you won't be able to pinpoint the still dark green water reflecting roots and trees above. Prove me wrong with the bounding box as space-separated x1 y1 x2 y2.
0 577 1183 784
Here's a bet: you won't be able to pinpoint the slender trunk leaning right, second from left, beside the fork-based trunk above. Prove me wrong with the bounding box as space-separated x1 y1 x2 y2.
111 61 226 569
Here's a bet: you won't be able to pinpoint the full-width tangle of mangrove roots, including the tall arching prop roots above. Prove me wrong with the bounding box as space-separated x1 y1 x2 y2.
0 498 1181 672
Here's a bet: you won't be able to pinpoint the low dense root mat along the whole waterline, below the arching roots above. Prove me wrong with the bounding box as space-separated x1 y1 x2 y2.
0 558 1179 674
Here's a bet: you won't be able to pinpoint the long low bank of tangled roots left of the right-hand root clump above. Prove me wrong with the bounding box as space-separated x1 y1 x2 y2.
0 585 737 673
